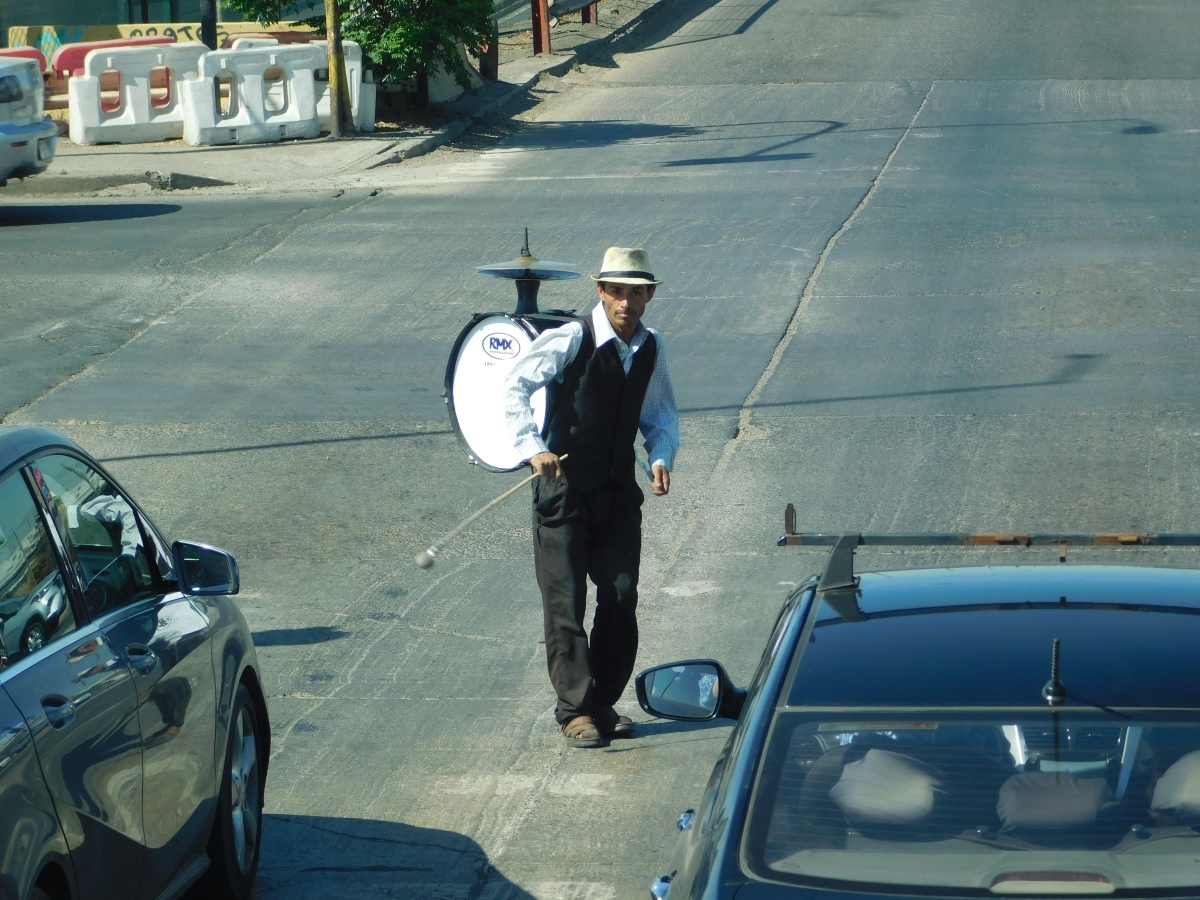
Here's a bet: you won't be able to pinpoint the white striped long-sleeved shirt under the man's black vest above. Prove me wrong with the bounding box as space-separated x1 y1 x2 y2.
504 302 679 472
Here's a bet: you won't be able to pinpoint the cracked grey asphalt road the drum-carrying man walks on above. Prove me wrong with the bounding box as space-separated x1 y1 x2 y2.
0 0 1200 900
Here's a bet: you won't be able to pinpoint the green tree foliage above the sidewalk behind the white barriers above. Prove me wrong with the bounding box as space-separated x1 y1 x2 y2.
223 0 492 88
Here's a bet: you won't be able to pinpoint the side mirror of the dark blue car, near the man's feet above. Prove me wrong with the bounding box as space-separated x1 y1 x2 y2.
636 659 746 722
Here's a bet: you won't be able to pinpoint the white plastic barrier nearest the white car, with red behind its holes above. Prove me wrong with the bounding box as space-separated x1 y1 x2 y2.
67 43 209 144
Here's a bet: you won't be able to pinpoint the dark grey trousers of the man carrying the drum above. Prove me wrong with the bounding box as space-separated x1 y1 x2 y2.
533 478 643 722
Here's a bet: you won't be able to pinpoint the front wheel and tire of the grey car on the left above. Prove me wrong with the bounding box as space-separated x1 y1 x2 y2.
204 684 265 900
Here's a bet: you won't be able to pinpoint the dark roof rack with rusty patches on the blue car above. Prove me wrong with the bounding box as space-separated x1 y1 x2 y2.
776 503 1200 622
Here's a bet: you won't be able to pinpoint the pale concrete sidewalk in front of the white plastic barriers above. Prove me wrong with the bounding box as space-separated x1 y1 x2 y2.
0 0 655 200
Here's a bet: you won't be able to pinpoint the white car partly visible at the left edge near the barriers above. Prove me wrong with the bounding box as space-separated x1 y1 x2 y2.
0 56 59 187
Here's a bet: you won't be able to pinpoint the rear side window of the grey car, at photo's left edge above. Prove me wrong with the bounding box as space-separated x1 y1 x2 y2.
0 472 76 662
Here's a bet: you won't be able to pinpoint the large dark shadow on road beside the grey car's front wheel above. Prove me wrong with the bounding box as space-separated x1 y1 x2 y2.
228 815 533 900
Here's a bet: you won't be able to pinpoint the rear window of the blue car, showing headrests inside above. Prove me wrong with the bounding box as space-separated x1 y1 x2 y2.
745 707 1200 896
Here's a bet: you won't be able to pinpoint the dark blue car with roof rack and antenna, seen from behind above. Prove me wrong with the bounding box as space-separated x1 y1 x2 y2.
636 529 1200 900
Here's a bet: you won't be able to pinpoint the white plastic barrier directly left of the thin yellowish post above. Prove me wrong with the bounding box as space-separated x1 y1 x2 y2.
181 43 325 146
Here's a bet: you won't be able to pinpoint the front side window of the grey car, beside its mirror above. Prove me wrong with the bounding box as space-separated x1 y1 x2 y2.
32 456 162 618
